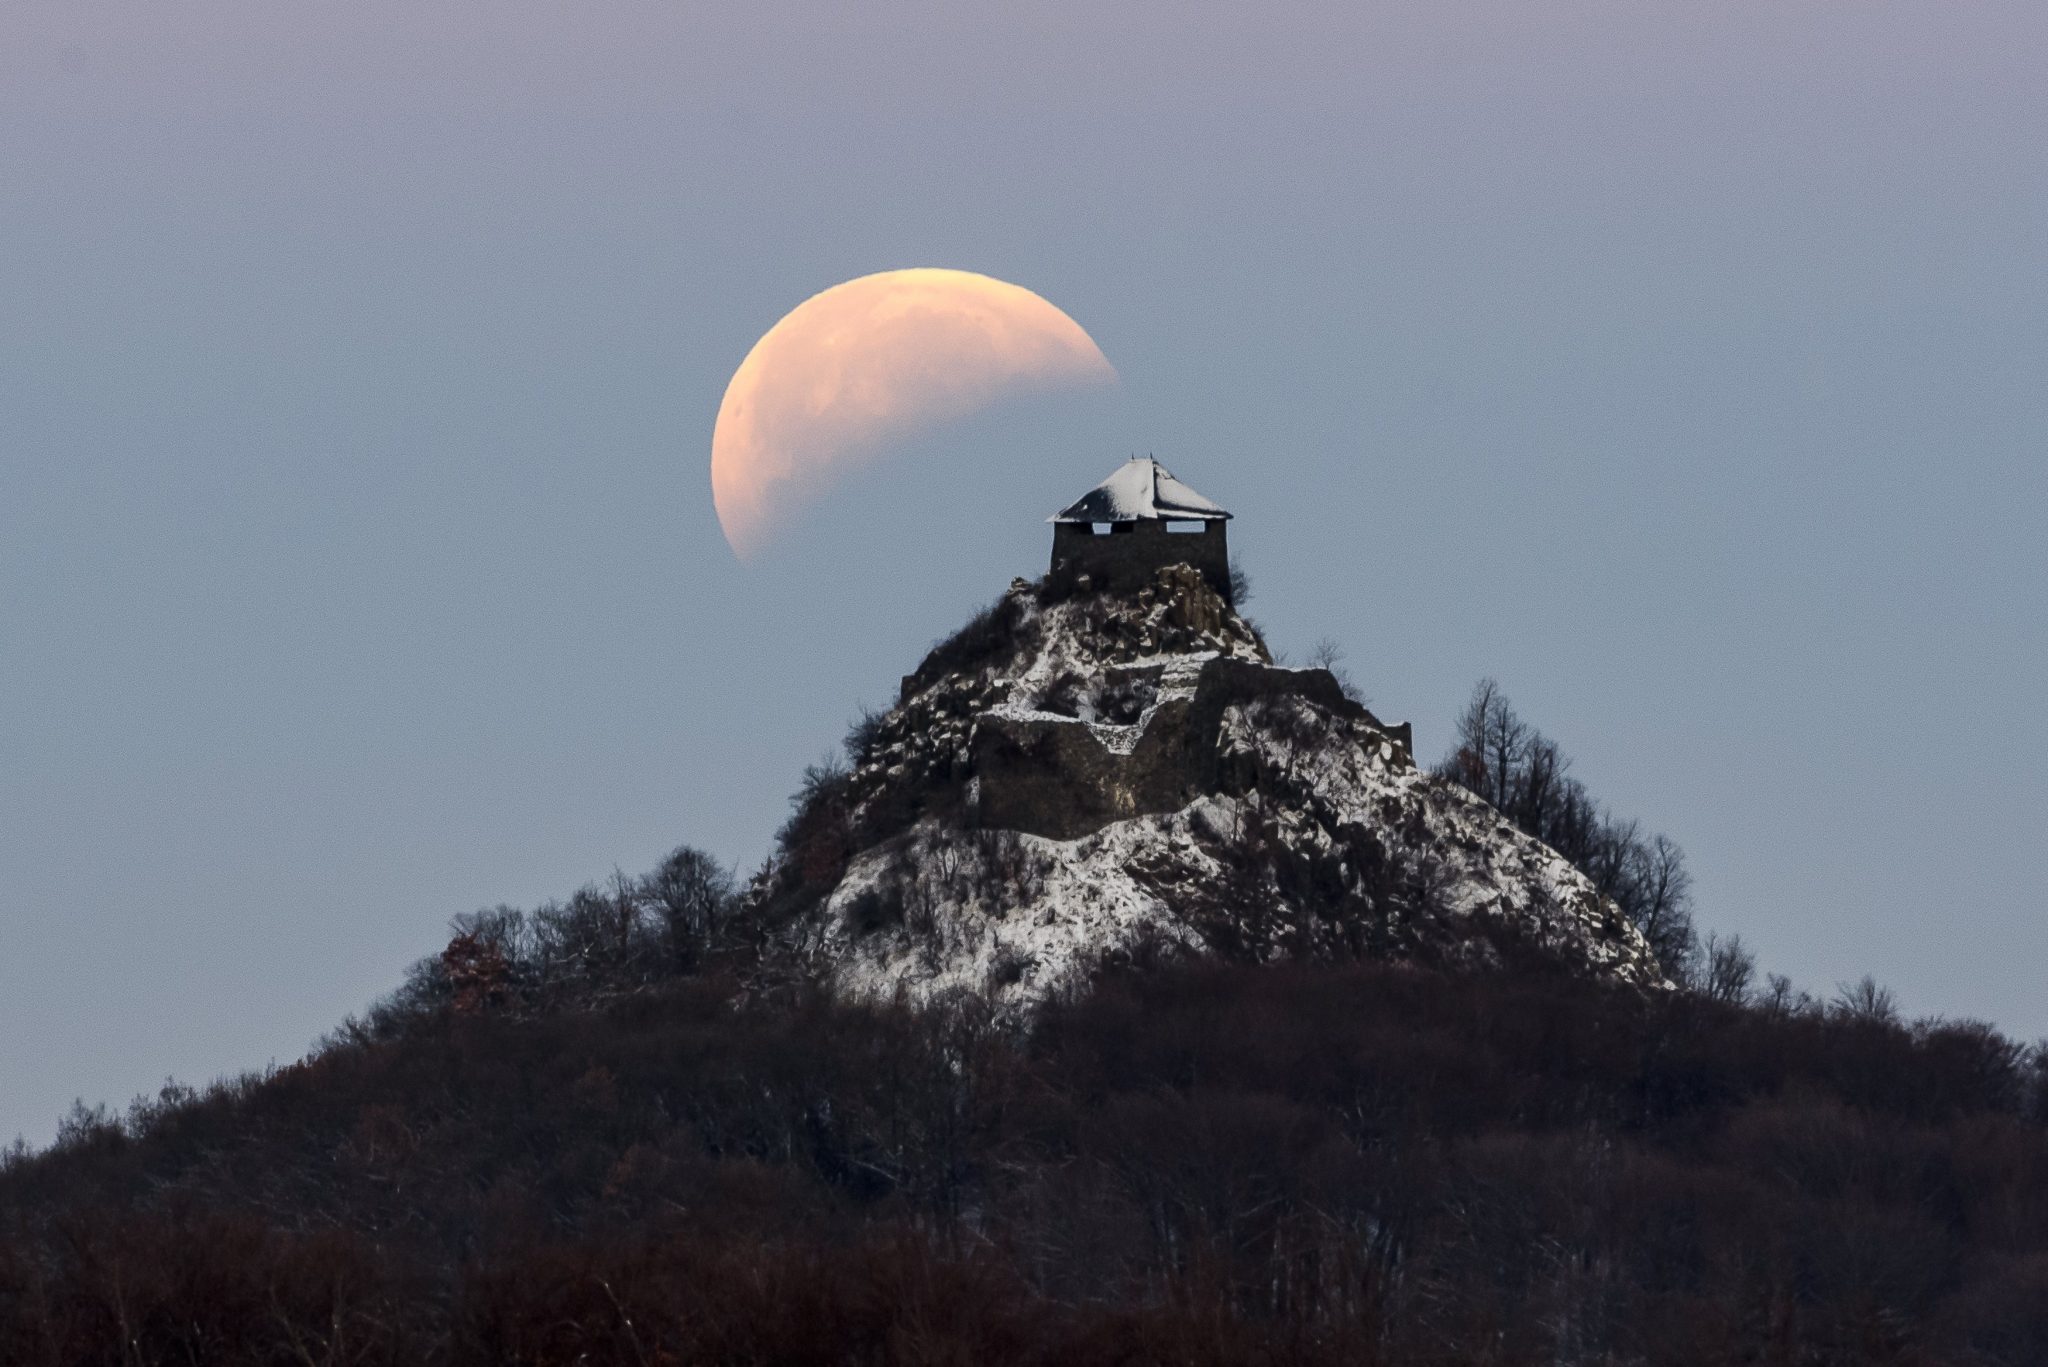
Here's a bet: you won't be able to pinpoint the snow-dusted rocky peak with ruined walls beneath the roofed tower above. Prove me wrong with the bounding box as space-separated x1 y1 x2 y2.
752 566 1661 1004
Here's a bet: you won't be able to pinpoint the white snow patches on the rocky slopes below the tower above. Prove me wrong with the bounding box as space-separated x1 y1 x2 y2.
778 569 1663 1008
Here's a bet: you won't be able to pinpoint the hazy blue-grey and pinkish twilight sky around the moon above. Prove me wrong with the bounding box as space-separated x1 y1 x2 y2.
0 0 2048 1144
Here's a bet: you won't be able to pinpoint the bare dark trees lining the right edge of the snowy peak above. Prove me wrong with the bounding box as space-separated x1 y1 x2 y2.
1438 678 1695 982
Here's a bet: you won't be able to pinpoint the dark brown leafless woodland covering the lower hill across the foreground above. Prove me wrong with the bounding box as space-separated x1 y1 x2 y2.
0 950 2048 1367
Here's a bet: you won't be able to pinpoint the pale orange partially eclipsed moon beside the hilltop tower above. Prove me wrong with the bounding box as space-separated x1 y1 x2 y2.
711 268 1116 560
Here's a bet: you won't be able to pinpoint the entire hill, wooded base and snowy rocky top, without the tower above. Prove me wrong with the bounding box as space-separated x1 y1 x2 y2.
0 570 2048 1367
